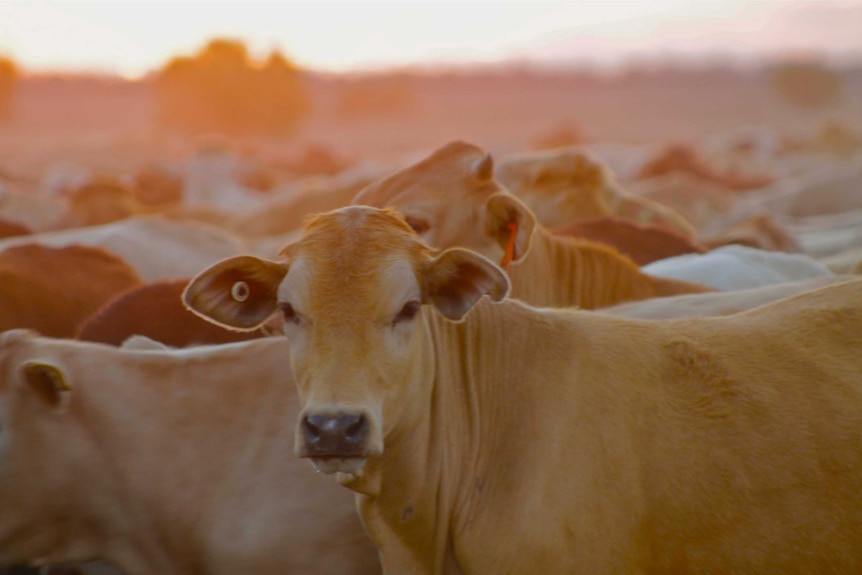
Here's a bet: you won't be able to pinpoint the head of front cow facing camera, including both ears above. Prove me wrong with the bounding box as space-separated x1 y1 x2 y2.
183 206 509 473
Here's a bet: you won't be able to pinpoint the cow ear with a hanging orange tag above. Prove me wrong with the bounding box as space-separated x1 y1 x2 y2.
485 192 536 262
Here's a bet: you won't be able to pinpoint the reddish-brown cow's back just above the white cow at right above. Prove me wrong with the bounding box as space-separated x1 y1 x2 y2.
552 216 706 265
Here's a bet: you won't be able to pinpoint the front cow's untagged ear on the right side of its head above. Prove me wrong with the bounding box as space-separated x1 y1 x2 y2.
422 248 509 321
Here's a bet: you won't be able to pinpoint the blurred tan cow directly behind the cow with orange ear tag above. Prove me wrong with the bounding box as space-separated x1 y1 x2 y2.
495 146 695 237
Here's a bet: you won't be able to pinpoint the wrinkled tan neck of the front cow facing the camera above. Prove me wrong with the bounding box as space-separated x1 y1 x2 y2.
344 308 492 575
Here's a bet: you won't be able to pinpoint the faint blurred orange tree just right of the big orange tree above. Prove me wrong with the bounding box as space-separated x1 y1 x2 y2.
336 75 417 118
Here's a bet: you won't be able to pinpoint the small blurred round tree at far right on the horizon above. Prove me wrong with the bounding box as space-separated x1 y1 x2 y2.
769 62 842 110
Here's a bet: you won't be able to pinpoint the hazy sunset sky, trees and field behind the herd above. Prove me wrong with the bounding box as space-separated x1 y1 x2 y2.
0 0 862 178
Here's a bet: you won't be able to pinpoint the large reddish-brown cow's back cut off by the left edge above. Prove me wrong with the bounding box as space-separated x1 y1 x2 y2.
0 244 141 337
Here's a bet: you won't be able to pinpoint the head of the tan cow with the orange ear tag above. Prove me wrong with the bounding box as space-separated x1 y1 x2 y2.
352 142 536 268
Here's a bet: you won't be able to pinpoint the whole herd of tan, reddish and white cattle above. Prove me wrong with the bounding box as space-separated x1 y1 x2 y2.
0 128 862 575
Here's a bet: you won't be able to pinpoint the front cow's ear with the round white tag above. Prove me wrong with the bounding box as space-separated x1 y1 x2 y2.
182 256 287 331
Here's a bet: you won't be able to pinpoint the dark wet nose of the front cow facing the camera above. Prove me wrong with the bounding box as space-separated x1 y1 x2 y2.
302 413 368 457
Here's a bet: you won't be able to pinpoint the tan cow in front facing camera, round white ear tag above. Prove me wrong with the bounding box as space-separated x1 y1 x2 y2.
185 206 862 575
